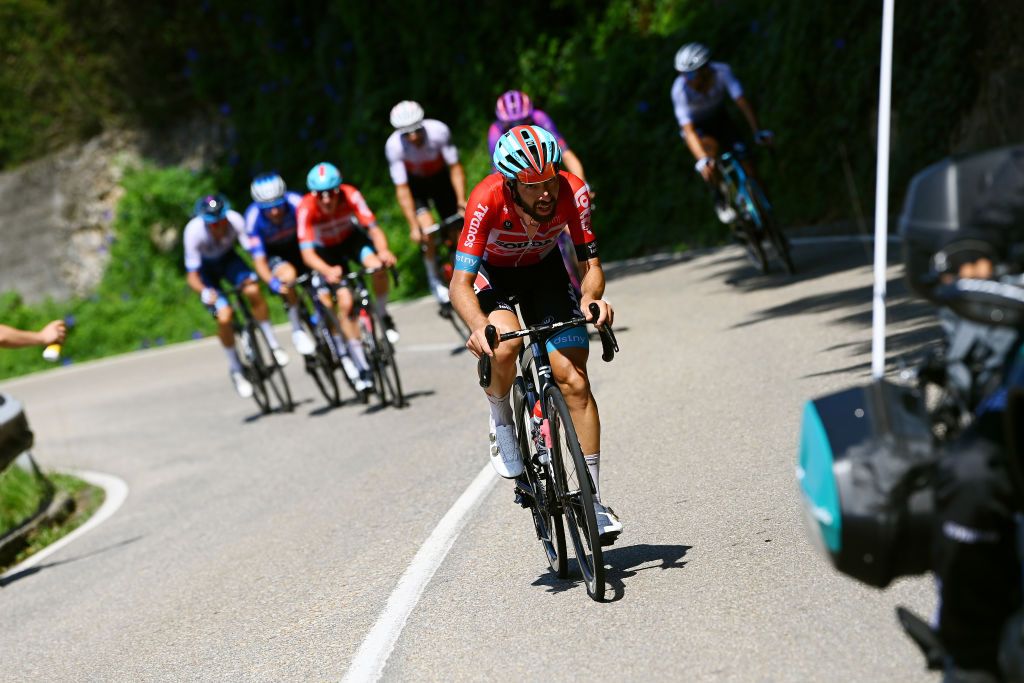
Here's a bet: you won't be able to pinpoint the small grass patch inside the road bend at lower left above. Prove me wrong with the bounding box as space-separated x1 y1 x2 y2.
0 467 104 571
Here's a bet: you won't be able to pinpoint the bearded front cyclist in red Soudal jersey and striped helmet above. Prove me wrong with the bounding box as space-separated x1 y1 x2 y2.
450 126 623 543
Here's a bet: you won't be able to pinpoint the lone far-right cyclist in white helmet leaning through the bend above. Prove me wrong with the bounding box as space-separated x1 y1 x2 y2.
672 43 773 223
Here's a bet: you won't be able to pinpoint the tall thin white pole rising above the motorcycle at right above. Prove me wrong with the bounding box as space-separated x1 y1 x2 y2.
871 0 896 379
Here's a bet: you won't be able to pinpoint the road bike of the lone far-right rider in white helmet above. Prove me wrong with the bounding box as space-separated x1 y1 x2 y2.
719 145 797 275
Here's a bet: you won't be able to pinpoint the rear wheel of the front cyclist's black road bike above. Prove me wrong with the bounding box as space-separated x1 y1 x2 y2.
512 377 568 579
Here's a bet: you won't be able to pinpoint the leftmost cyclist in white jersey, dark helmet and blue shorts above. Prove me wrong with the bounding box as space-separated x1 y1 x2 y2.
182 195 288 398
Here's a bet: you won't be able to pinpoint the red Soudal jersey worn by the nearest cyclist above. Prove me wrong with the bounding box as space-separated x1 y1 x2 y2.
456 171 597 272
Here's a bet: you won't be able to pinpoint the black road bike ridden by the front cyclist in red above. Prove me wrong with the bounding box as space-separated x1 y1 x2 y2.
477 304 618 602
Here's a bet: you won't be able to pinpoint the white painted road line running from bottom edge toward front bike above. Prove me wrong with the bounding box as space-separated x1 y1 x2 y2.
342 464 498 683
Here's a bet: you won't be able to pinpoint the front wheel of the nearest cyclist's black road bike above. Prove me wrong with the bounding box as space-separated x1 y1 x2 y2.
544 385 605 602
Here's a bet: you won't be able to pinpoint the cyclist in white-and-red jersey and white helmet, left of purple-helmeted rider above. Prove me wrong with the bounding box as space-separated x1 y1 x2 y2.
384 100 466 305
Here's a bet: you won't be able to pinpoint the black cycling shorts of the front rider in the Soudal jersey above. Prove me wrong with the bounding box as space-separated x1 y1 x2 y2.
476 249 582 326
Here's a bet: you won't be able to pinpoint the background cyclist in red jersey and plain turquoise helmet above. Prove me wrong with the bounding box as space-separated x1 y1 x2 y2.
296 162 398 391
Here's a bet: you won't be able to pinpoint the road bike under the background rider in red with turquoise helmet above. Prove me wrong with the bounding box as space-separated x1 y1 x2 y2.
342 268 406 408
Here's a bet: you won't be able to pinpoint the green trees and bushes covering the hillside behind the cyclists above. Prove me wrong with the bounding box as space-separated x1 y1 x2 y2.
0 0 1013 377
